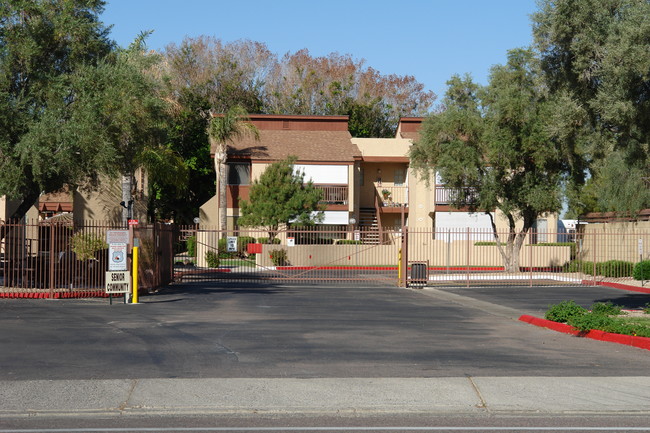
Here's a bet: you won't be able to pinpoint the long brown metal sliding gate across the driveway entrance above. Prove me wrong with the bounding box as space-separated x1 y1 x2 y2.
174 227 401 286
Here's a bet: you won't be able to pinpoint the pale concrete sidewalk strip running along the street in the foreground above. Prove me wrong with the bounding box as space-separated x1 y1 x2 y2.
0 377 650 418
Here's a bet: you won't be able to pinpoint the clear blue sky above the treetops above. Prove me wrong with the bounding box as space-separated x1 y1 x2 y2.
101 0 536 96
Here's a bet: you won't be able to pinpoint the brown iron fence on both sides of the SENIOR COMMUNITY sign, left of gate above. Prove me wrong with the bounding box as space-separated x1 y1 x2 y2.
0 219 175 297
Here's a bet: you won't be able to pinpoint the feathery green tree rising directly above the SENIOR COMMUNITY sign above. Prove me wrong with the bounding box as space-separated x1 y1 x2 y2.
71 34 187 225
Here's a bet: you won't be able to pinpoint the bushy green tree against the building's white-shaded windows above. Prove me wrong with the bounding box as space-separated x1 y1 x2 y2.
239 156 323 241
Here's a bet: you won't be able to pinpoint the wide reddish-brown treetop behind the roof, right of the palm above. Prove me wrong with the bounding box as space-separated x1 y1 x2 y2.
263 49 435 137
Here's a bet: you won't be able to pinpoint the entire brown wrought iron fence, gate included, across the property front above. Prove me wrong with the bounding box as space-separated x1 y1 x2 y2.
0 221 650 295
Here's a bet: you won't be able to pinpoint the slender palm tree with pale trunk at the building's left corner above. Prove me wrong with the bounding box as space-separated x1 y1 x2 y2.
208 105 260 237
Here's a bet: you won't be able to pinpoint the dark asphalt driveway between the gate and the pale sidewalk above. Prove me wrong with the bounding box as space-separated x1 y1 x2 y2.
0 283 650 380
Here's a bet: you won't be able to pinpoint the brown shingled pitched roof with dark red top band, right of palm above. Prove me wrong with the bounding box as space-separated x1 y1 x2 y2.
213 114 361 162
